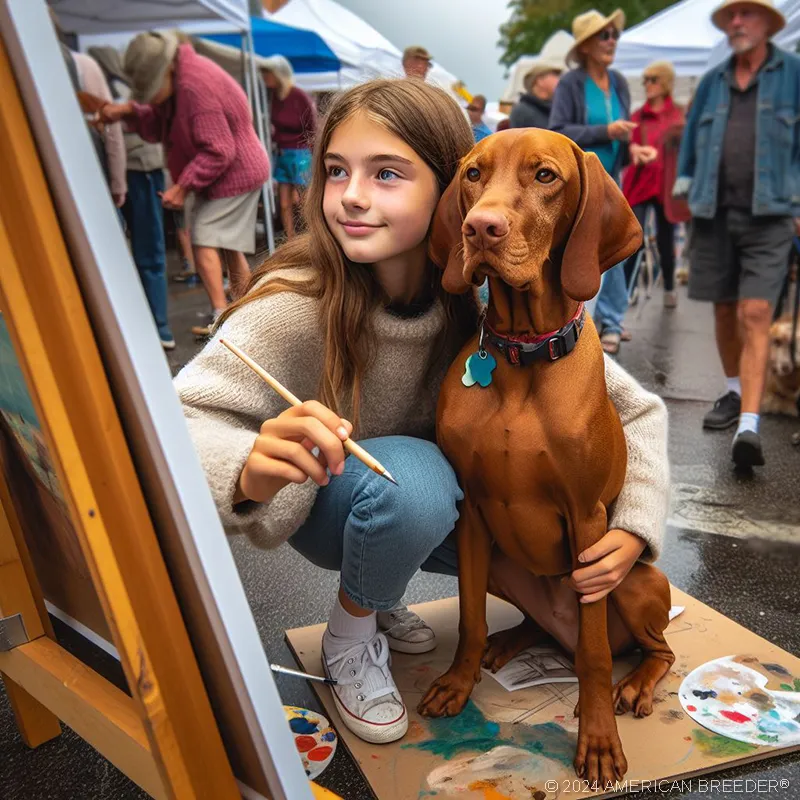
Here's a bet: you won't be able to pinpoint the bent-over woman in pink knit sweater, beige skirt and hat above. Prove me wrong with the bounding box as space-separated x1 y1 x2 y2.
101 33 269 335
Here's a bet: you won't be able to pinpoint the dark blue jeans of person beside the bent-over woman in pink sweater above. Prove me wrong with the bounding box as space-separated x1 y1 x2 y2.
124 169 172 341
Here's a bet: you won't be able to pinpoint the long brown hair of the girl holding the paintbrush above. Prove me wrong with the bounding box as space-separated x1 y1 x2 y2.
218 79 477 429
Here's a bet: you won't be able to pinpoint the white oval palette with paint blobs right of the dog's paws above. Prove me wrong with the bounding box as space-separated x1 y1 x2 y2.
679 656 800 747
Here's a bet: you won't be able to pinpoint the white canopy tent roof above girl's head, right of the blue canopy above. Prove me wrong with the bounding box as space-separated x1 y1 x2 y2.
265 0 457 93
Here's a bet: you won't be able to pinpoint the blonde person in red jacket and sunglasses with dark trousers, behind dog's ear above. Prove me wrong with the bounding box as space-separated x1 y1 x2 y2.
622 61 683 308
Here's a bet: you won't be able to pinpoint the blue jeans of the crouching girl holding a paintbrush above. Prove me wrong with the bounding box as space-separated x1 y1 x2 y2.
289 436 464 611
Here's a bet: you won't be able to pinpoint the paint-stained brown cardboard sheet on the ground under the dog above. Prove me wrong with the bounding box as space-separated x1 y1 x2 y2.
287 587 800 800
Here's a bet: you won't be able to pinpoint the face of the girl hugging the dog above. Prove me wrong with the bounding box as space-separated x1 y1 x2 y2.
322 114 439 264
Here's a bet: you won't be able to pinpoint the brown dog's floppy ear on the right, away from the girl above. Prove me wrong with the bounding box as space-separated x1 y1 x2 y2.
561 144 642 300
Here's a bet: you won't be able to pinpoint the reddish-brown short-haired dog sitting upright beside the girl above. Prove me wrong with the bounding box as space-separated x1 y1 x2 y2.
419 130 674 785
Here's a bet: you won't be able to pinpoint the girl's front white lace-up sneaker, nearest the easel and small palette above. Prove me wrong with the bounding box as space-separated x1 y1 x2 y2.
322 631 408 744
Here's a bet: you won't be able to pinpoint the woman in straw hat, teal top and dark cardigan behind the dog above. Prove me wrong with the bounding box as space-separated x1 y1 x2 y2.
550 9 636 354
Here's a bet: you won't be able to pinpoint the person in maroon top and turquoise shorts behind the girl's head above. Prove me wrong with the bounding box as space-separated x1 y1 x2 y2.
261 56 317 239
